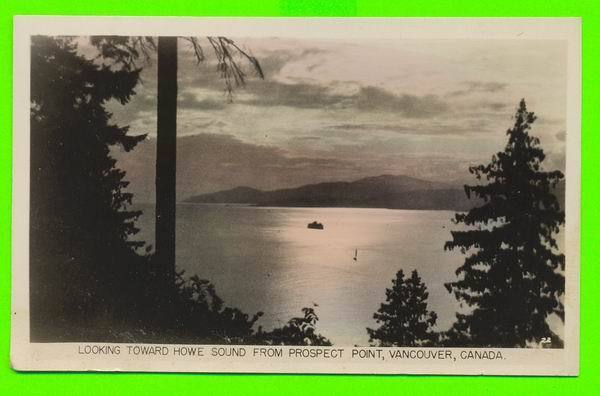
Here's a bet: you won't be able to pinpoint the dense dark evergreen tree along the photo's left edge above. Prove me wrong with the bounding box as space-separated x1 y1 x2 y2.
30 37 145 339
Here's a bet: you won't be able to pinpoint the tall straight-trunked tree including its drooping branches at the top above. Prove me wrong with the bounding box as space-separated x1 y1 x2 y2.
91 36 264 284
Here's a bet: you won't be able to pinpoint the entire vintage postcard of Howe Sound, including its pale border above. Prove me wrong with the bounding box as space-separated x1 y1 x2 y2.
11 16 581 375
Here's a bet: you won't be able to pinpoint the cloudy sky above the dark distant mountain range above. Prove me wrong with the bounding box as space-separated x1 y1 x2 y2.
103 38 566 202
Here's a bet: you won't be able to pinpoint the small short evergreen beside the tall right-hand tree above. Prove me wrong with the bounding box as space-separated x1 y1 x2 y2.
367 270 437 346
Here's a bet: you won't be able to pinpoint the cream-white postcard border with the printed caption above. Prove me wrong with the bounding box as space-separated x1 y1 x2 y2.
11 16 581 375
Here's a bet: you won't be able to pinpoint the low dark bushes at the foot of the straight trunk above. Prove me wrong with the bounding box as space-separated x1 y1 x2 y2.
91 270 331 345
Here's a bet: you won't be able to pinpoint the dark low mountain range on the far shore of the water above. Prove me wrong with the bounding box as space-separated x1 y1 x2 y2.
184 175 473 211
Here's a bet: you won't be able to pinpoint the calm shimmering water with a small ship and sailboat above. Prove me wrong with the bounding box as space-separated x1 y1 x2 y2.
132 204 564 345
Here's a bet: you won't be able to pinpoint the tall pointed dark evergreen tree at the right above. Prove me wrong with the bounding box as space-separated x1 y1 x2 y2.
445 100 565 347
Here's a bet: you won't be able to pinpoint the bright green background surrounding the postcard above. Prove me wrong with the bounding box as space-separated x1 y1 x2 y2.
0 0 600 395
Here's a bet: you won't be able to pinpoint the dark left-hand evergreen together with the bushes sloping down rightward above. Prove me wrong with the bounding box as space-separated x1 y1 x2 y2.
30 37 328 345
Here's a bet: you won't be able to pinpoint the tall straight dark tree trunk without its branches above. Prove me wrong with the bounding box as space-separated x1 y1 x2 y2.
156 37 177 279
